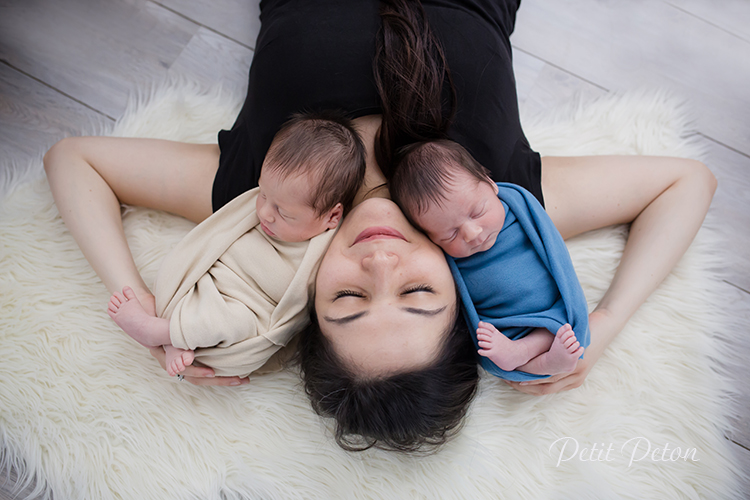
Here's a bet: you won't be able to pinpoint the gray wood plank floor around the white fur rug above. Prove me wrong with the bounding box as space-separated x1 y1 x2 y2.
0 0 750 499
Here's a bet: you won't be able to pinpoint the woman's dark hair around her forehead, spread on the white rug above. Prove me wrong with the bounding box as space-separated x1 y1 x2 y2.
297 306 479 453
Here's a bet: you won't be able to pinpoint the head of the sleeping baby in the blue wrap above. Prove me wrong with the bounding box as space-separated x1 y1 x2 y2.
390 140 505 258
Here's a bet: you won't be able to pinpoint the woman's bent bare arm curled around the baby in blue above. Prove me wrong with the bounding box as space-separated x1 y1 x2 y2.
509 156 716 394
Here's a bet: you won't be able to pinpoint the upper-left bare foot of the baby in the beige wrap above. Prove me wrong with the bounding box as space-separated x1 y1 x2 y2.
107 286 169 347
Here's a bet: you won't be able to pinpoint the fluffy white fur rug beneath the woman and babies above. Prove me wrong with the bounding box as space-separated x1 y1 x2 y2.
0 85 738 500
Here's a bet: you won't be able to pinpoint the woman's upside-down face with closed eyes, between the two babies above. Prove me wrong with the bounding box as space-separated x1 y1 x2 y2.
315 198 456 375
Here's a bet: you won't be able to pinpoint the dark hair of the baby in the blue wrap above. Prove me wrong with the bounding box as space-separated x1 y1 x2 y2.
389 139 492 227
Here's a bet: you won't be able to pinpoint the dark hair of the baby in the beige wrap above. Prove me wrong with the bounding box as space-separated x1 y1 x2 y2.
263 111 366 215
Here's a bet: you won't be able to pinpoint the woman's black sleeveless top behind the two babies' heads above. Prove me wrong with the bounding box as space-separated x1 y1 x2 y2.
212 0 543 210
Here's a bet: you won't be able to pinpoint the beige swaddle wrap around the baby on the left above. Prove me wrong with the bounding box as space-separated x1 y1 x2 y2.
154 188 334 377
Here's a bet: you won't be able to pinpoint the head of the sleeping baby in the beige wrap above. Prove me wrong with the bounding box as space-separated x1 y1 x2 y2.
256 113 365 242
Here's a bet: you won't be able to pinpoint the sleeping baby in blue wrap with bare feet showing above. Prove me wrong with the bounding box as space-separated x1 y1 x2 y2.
390 140 589 381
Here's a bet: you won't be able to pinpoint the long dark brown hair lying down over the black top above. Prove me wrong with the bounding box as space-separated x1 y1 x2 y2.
373 0 456 180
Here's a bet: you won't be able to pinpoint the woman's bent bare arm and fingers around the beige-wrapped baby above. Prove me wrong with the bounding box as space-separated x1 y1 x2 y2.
44 137 243 385
